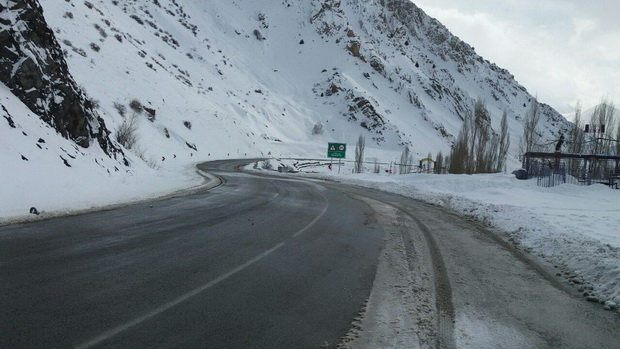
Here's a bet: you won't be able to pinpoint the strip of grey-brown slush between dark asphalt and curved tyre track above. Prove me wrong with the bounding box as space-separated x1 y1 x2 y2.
339 199 428 349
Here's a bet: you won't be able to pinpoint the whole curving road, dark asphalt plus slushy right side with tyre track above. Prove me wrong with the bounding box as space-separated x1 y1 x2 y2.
0 160 620 348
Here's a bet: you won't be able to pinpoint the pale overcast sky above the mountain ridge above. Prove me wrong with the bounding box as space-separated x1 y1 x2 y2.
413 0 620 113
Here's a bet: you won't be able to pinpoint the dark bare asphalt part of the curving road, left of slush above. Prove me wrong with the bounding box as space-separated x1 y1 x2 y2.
0 162 383 348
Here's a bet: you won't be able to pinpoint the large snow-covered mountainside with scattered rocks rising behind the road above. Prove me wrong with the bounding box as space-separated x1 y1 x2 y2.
0 0 566 218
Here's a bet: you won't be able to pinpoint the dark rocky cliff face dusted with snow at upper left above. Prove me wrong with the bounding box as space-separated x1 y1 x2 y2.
0 0 118 154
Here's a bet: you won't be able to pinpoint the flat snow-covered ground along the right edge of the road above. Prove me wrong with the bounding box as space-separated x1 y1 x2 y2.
251 160 620 305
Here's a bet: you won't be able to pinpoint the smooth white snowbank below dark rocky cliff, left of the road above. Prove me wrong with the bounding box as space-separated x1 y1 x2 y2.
0 83 200 219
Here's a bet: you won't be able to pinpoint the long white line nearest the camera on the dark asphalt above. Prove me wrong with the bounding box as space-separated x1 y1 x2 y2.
76 242 284 349
